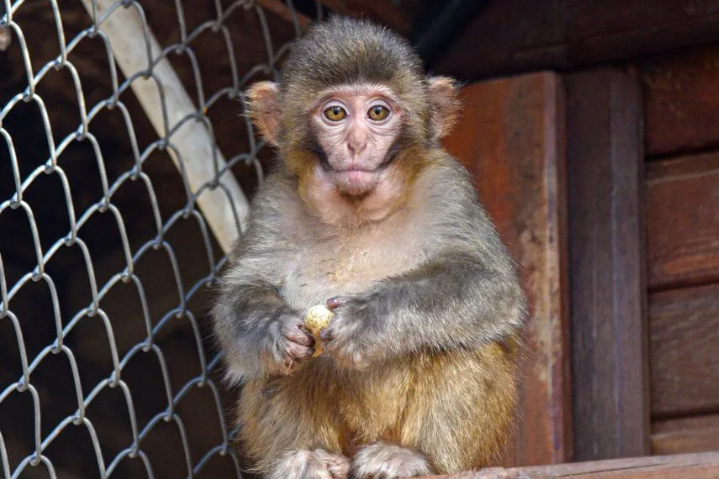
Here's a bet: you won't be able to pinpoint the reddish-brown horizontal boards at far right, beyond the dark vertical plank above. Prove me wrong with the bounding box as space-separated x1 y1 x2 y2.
634 46 719 454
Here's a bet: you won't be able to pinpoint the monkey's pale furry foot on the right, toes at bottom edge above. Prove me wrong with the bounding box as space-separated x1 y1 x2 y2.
350 442 432 479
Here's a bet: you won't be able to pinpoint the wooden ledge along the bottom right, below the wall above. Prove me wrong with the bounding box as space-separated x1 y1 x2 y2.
414 452 719 479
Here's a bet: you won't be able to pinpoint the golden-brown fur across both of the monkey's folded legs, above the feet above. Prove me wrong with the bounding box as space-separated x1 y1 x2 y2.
240 343 516 474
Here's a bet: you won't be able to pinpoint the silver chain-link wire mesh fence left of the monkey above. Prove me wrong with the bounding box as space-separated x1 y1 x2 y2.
0 0 314 479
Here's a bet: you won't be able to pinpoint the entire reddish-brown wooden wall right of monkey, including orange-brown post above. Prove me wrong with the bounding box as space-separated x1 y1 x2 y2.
447 46 719 464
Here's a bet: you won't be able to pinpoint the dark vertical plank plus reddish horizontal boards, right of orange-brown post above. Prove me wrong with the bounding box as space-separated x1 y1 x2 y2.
562 45 719 460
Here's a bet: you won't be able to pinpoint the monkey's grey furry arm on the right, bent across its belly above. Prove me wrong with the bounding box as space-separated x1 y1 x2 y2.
323 251 525 362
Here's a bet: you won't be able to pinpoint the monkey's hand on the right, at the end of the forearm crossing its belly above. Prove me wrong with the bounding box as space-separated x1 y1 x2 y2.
320 295 381 369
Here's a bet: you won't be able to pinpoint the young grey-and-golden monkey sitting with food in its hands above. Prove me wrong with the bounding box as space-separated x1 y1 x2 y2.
212 17 526 479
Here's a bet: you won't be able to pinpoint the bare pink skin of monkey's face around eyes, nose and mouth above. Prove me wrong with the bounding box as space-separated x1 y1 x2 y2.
312 85 402 195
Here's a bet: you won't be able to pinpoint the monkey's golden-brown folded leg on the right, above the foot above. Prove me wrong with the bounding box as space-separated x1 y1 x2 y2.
401 340 517 474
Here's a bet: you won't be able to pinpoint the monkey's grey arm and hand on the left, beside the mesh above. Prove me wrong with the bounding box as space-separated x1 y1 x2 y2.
212 179 314 382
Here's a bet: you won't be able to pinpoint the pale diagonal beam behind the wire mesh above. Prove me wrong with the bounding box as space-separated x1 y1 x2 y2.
82 0 249 253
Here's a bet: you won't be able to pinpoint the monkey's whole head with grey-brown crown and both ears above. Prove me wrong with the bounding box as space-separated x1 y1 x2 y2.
247 17 458 224
